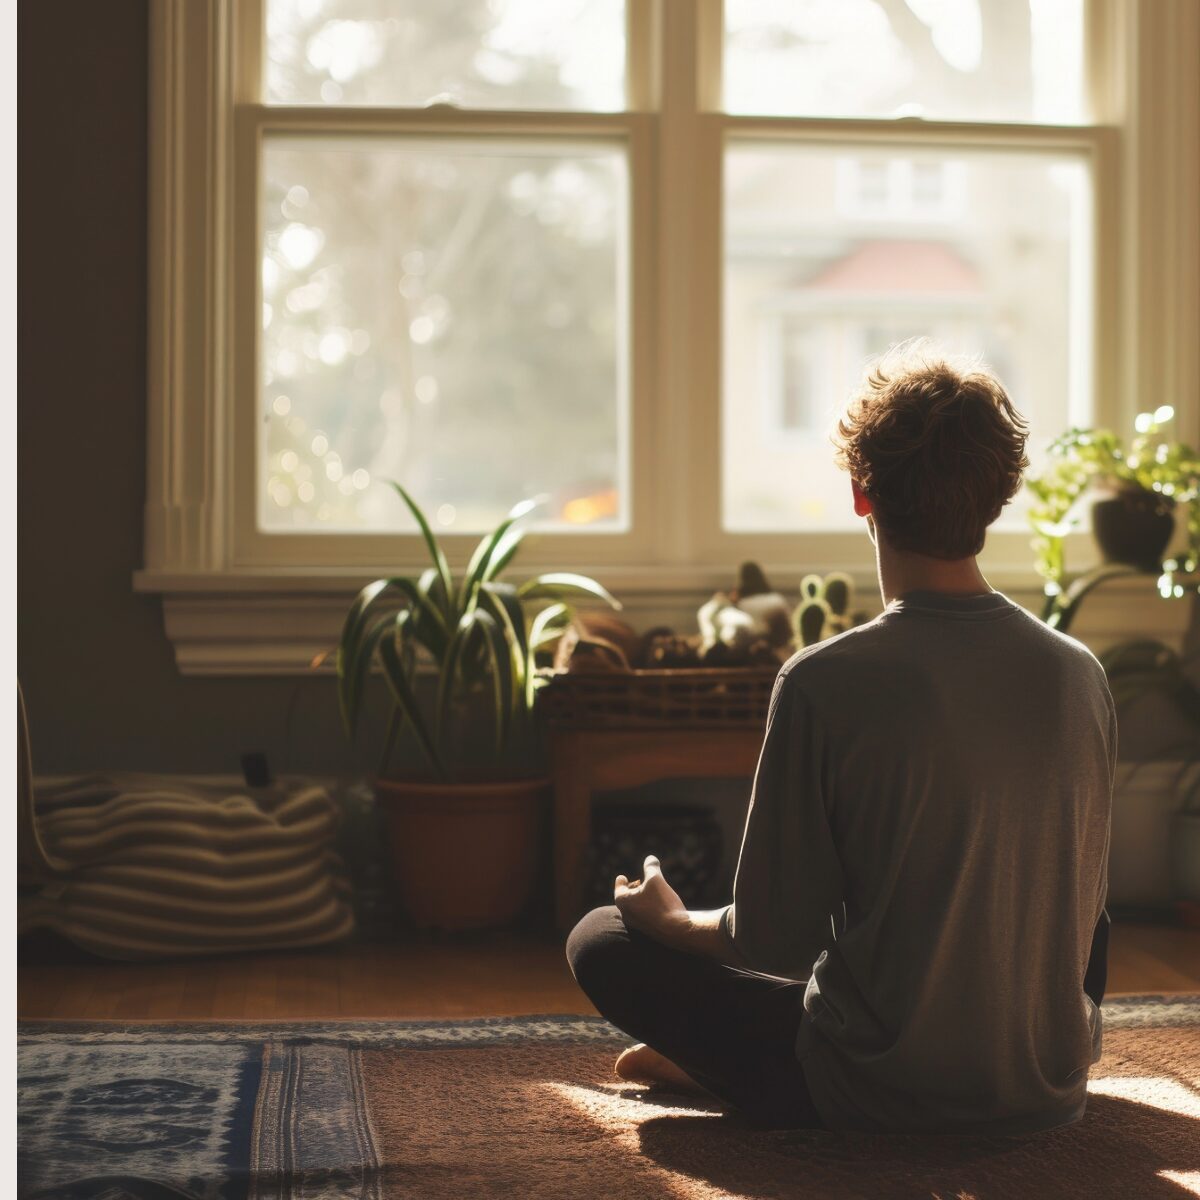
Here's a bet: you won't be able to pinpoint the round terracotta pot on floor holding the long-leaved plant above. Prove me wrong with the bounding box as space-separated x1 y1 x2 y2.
376 779 550 931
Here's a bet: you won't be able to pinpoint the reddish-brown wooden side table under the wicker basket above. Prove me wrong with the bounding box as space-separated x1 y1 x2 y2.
551 724 763 930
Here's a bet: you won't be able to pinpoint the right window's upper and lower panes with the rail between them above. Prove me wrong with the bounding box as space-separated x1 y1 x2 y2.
721 0 1096 534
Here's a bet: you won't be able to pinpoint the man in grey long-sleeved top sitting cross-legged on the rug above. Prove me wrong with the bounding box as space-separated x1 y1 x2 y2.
568 347 1116 1134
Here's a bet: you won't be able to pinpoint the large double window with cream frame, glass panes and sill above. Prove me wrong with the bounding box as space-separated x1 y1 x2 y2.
139 0 1200 670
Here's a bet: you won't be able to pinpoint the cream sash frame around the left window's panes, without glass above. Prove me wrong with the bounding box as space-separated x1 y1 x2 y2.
232 0 653 568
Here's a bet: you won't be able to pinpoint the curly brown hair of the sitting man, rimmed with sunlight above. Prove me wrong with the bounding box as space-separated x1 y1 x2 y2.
834 343 1030 559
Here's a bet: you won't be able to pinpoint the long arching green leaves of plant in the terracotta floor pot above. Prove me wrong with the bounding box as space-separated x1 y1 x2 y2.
337 484 620 780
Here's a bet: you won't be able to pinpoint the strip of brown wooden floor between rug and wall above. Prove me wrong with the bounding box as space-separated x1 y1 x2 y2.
17 924 1200 1021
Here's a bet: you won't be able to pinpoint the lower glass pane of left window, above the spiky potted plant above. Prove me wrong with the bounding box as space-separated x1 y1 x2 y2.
259 138 628 533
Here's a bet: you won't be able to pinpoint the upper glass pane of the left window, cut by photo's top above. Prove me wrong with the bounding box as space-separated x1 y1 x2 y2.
265 0 625 112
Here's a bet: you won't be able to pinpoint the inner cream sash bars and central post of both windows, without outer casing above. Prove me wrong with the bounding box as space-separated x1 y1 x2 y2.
232 0 1120 578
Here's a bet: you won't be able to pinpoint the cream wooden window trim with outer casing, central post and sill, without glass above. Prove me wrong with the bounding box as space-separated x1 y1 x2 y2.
134 0 1200 674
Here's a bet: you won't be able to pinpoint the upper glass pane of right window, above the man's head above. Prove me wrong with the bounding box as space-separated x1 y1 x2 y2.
725 0 1084 122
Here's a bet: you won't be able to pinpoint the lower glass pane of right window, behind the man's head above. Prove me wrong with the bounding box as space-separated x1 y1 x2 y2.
722 146 1091 530
